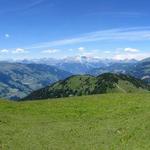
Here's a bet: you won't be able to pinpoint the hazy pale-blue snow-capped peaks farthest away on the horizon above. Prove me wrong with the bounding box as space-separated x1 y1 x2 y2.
19 56 138 75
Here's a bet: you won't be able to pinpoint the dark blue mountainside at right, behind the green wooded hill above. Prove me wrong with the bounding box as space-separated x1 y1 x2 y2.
87 58 150 83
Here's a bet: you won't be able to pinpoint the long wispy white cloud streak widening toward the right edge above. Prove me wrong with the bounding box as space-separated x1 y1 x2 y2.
26 27 150 49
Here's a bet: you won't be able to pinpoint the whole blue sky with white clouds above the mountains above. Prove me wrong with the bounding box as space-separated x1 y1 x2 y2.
0 0 150 60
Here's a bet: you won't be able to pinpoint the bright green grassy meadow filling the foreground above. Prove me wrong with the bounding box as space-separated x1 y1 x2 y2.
0 94 150 150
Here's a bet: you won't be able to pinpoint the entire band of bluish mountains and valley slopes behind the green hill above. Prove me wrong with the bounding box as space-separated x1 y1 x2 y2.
0 56 150 100
